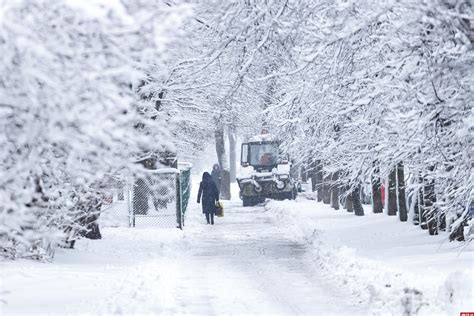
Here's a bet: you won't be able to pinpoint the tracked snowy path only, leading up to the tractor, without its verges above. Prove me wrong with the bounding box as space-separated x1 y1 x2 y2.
170 204 366 315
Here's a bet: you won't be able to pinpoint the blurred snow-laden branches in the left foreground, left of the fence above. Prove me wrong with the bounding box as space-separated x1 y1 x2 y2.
0 1 183 257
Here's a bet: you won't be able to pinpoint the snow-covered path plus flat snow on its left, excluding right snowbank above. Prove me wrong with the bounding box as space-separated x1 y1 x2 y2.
2 202 365 315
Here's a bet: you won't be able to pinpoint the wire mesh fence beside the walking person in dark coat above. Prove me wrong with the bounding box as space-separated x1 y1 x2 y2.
100 164 191 229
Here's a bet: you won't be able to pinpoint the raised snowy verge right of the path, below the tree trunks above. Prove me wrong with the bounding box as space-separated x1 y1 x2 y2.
266 199 474 315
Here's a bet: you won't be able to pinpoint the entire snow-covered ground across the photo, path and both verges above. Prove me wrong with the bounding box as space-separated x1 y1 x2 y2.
0 186 474 315
